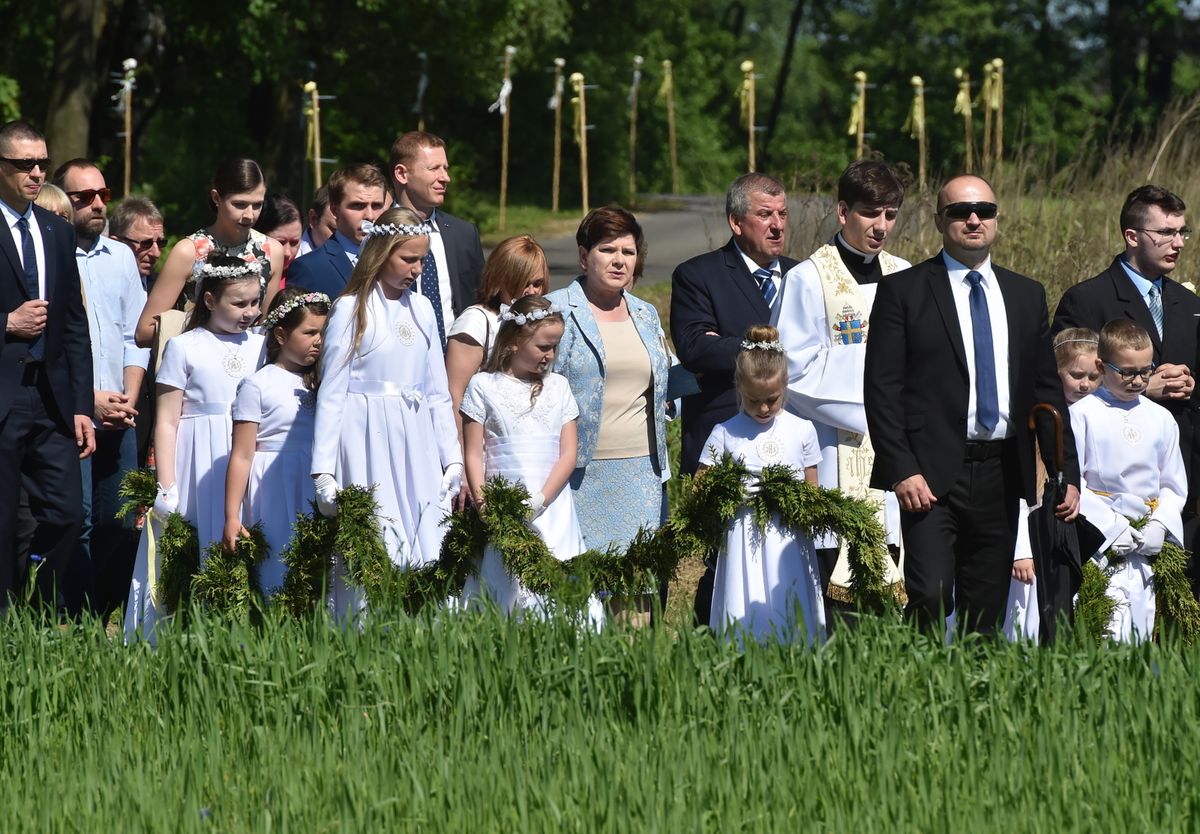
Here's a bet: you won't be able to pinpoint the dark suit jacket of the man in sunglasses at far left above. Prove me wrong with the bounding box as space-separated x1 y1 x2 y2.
0 205 94 427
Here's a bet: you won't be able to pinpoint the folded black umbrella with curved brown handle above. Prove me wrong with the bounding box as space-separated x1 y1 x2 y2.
1030 403 1104 643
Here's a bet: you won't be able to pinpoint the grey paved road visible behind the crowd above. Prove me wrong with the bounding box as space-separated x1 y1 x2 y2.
539 194 730 289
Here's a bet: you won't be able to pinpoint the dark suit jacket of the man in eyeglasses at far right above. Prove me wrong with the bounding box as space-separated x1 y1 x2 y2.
1054 256 1200 475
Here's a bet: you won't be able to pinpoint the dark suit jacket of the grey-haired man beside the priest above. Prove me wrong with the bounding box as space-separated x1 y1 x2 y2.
671 238 798 474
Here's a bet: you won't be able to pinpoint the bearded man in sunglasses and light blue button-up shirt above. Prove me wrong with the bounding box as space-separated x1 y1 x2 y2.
54 158 150 614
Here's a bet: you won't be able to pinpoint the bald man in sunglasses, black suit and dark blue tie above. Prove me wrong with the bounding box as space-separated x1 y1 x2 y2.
864 175 1079 636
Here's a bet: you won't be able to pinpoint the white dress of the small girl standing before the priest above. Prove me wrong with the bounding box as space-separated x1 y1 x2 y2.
700 412 826 643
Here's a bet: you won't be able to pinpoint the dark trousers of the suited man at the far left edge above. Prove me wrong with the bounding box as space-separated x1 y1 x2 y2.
0 380 83 612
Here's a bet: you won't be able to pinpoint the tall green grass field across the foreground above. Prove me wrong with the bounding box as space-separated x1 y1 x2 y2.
9 614 1200 833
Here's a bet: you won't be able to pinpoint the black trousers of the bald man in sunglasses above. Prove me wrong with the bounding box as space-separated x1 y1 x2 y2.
900 440 1021 636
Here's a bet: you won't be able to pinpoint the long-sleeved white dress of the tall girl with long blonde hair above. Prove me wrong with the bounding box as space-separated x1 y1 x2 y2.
312 284 462 616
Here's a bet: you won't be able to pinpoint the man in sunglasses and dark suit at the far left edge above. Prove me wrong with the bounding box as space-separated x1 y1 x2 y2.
0 121 96 612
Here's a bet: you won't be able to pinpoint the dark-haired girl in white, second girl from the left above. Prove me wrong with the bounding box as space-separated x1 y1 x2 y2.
222 287 329 592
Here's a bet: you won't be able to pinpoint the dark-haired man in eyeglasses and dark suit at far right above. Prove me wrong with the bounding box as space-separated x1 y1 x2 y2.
1054 185 1200 521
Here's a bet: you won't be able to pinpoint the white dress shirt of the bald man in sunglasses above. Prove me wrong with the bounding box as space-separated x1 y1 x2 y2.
942 251 1012 440
